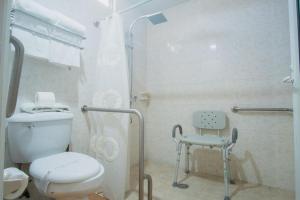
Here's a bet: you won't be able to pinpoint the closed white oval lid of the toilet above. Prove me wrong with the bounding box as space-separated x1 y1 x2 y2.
29 152 103 183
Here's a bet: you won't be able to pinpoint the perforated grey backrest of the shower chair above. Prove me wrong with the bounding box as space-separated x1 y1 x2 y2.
193 111 226 135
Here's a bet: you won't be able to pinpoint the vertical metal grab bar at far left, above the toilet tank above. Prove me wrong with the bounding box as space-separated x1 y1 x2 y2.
6 36 24 118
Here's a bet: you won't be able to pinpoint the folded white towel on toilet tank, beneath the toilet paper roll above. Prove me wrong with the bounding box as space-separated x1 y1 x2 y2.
21 103 70 114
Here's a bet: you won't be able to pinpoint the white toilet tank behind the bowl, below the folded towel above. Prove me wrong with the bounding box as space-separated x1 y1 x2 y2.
7 112 73 163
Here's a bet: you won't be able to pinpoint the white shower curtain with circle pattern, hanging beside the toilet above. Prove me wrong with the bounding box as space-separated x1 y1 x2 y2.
90 14 129 200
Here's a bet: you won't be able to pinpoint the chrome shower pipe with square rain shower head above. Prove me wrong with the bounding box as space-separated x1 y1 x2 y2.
128 12 168 108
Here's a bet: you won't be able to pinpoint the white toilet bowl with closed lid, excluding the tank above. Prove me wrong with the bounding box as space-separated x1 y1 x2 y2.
29 152 104 199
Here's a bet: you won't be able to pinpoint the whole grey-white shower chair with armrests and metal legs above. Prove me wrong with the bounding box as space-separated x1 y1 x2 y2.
172 111 238 200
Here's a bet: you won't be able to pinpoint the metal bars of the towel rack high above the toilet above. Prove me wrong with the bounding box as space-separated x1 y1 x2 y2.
10 9 86 49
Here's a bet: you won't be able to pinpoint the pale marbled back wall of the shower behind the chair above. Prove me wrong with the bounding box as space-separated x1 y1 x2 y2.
146 0 294 190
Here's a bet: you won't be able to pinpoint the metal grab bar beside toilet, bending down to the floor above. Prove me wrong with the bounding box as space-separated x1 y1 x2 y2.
81 105 152 200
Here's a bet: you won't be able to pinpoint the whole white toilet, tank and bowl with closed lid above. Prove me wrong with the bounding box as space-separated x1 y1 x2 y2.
8 112 104 200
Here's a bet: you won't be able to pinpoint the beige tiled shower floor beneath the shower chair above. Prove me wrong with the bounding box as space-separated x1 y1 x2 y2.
127 163 295 200
